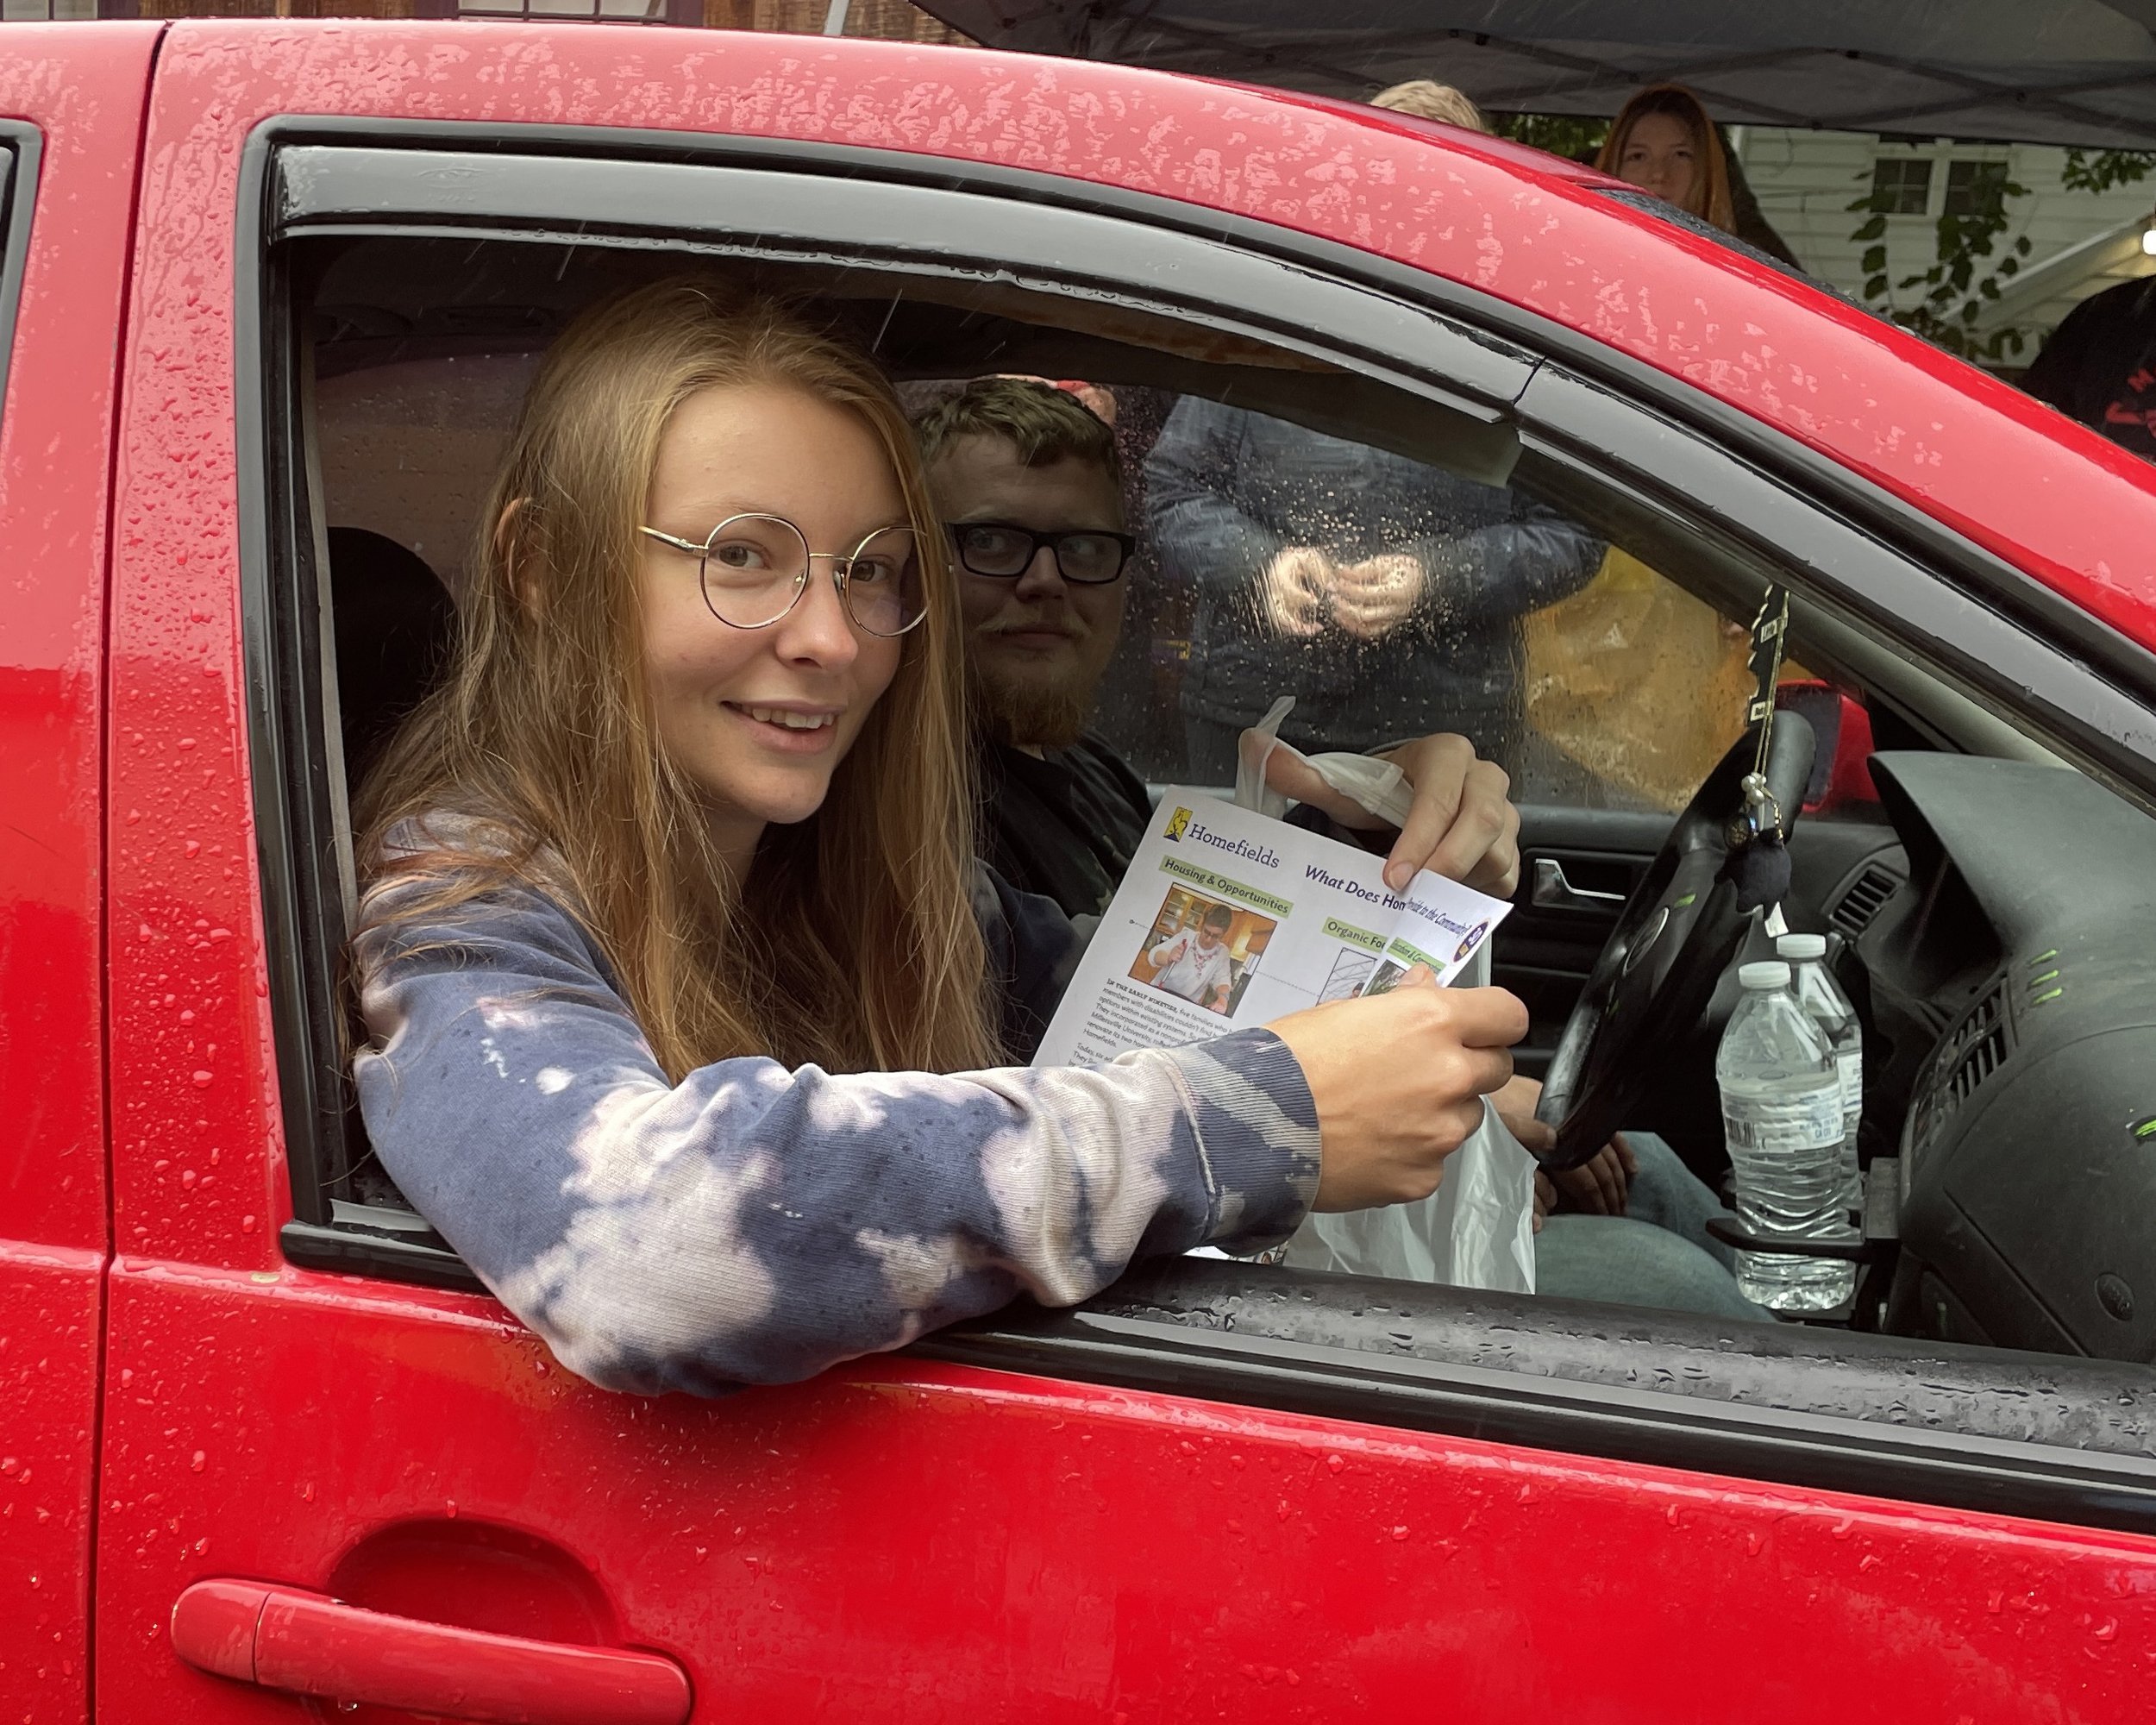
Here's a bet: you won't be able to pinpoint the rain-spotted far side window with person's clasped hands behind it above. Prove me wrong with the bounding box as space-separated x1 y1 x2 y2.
1091 388 1751 811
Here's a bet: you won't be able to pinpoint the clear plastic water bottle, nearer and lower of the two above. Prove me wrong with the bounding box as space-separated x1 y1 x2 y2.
1714 960 1857 1311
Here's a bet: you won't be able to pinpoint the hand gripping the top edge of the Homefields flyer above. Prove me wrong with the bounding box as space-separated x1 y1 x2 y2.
1266 731 1520 900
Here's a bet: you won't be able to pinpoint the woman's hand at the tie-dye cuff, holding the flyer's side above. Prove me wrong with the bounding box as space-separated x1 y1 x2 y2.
1270 964 1526 1210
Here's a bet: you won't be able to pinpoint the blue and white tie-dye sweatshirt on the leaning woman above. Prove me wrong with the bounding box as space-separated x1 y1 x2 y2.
354 828 1318 1396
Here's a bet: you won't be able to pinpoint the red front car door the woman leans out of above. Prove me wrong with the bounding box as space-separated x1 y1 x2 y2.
97 24 2156 1725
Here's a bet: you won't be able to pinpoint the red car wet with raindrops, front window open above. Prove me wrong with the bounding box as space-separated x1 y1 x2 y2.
0 22 2156 1725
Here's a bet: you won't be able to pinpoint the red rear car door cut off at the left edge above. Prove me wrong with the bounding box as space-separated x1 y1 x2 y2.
0 26 155 1725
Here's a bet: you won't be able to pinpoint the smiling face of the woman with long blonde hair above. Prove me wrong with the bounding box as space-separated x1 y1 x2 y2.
641 384 908 871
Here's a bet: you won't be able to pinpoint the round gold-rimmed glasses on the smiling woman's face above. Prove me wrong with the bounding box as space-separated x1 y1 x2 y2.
638 513 927 637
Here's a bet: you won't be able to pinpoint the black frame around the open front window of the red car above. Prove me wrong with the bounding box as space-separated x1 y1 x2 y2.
237 116 2156 1531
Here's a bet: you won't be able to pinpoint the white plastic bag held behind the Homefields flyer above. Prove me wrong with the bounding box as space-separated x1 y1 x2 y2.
1236 694 1535 1294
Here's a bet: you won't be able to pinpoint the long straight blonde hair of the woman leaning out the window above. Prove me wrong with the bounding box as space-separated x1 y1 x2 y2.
358 280 999 1081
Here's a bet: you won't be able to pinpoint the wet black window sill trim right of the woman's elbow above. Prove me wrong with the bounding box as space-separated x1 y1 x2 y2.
908 1259 2156 1534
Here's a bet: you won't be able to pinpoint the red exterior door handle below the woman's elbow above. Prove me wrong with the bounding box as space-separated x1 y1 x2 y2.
172 1581 690 1725
